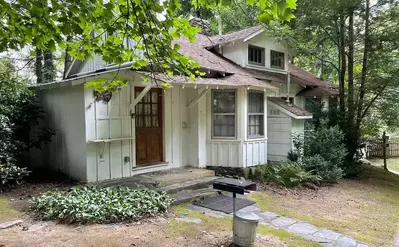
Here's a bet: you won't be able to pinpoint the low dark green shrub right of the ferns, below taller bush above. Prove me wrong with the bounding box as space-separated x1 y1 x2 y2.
301 155 343 183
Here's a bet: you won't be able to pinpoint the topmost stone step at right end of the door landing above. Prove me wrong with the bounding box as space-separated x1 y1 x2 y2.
151 168 215 187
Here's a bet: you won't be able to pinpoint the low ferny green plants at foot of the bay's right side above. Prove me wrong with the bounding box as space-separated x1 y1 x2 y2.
257 162 321 187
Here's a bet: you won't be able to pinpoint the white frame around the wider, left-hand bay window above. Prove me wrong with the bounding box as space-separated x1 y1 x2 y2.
211 89 238 140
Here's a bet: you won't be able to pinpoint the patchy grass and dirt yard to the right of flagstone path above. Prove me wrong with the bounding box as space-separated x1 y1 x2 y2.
249 166 399 246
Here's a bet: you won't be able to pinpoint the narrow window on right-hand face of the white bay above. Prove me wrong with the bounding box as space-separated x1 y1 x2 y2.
248 92 265 138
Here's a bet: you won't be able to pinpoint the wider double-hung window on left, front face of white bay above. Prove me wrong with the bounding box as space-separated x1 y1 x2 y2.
212 90 236 138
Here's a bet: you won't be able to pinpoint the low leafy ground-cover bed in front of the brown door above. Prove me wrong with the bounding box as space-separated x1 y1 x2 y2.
32 187 172 223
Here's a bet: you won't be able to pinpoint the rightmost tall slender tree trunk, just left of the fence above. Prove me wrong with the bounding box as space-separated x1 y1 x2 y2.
356 0 370 130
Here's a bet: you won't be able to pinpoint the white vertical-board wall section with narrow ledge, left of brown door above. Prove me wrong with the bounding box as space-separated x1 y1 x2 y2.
85 86 134 182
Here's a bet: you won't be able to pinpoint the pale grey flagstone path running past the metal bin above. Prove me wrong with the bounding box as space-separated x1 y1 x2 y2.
188 205 371 247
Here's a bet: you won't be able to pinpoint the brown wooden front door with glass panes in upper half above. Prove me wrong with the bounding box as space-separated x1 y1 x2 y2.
135 88 163 166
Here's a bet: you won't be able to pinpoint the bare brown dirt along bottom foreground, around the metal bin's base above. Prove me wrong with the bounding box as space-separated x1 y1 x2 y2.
0 219 285 247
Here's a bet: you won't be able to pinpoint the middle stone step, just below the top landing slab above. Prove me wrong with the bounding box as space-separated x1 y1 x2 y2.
159 176 220 194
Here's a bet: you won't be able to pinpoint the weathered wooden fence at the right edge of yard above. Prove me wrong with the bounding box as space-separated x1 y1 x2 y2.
367 137 399 158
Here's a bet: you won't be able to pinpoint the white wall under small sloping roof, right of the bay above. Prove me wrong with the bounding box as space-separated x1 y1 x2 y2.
267 105 292 161
